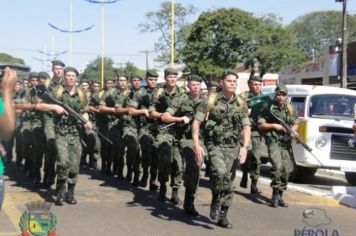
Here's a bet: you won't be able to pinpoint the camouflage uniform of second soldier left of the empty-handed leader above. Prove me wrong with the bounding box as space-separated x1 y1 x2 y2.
149 86 185 201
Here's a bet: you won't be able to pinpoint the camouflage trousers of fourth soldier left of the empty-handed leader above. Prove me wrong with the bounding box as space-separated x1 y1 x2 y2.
123 127 142 176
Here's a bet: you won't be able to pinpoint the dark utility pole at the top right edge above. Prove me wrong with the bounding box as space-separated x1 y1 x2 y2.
335 0 347 88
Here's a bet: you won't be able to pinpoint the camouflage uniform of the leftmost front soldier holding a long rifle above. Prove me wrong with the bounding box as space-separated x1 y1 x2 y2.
54 85 87 205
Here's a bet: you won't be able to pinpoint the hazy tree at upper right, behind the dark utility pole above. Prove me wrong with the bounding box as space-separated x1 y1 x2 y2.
288 11 356 59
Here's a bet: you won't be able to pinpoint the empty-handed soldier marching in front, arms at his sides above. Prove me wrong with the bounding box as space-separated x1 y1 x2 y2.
192 70 250 228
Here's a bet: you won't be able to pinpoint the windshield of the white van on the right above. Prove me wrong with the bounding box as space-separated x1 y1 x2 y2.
309 94 356 119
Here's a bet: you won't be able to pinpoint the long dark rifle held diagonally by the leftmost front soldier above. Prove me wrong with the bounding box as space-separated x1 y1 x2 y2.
36 85 113 144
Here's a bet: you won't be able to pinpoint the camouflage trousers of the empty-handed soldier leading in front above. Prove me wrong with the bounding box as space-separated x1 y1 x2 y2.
207 143 238 207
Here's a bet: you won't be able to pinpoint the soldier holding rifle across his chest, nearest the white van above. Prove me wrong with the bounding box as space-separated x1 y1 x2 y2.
258 84 298 207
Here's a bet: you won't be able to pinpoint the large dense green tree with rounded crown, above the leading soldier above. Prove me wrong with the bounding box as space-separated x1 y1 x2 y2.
182 8 303 79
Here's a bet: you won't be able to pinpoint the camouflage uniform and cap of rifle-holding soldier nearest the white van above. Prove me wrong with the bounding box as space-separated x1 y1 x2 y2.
258 85 298 205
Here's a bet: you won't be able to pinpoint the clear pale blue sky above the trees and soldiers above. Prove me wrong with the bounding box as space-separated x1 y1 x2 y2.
0 0 356 71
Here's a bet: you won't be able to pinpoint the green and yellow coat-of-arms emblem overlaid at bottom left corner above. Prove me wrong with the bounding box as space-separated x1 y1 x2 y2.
19 201 57 236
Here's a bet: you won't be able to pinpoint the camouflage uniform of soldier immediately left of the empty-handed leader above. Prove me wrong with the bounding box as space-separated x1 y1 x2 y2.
167 89 206 215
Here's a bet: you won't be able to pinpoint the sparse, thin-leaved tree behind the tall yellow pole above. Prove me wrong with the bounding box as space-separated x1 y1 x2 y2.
138 2 196 64
